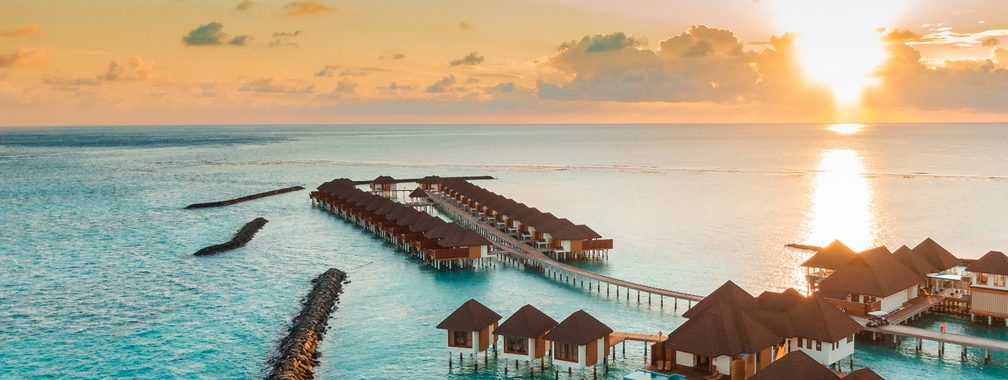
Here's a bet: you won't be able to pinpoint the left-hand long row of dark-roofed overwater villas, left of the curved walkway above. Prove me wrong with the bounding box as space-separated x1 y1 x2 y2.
309 178 491 267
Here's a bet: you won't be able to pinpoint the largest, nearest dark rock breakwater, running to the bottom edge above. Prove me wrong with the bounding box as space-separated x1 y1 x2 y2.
266 268 349 380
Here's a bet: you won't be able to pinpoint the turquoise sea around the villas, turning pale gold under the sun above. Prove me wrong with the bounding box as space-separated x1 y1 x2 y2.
0 124 1008 379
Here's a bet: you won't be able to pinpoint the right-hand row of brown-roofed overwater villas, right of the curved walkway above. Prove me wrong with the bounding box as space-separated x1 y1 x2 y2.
420 177 613 258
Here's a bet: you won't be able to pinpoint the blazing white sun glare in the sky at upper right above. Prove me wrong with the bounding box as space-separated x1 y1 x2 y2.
770 0 909 104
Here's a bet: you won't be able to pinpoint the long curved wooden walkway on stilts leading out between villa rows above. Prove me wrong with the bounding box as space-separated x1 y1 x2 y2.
426 192 704 308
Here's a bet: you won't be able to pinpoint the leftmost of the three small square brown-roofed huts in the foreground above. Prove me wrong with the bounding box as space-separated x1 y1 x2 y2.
437 299 501 360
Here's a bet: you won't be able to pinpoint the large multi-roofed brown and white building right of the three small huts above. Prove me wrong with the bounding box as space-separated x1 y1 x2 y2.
651 281 862 379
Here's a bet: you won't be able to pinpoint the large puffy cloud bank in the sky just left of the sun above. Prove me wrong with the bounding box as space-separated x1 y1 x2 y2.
536 25 760 102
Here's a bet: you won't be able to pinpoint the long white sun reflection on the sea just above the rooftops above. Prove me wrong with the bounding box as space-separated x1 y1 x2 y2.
804 149 877 251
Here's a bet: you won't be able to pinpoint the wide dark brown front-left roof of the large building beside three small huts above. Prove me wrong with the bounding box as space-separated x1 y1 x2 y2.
664 299 781 358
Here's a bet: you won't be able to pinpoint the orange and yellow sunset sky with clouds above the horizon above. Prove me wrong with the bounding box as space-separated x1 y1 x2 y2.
0 0 1008 126
